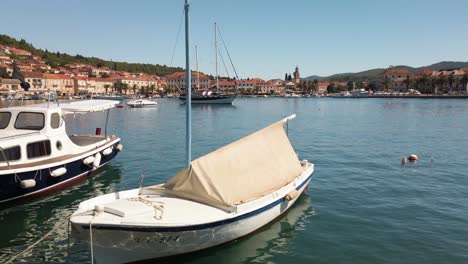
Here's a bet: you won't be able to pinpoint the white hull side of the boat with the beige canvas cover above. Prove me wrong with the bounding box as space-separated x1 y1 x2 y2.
72 169 312 263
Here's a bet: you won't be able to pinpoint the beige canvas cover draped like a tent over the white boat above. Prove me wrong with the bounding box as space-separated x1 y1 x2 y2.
148 121 304 208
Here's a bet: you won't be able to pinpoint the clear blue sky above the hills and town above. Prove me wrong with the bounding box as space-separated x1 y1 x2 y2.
0 0 468 79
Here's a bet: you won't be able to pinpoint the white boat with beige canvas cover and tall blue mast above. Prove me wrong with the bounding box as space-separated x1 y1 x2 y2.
70 0 314 263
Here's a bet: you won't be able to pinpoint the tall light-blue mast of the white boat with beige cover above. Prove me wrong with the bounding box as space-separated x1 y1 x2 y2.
185 0 192 168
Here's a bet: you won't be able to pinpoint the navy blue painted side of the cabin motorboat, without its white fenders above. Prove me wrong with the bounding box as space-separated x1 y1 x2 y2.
0 142 119 204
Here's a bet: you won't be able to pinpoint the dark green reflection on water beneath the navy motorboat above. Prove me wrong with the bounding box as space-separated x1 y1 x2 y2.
0 164 122 263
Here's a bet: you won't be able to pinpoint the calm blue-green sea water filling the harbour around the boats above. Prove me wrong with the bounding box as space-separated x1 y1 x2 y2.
0 98 468 263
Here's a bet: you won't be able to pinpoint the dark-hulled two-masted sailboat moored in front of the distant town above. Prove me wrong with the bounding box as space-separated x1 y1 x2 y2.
179 23 237 104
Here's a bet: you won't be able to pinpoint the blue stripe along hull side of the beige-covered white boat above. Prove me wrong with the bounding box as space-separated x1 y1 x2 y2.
81 170 312 232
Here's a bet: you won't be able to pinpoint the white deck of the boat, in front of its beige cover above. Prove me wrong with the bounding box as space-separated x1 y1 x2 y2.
73 189 233 227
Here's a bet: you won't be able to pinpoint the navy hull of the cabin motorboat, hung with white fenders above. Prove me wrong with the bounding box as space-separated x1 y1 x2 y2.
0 139 120 206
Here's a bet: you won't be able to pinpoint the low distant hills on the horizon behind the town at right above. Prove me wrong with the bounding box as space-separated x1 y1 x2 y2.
302 61 468 81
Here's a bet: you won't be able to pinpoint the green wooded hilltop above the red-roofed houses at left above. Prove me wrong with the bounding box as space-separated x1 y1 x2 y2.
0 34 183 76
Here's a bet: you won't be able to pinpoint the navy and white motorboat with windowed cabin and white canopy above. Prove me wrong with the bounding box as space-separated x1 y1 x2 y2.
0 100 122 204
